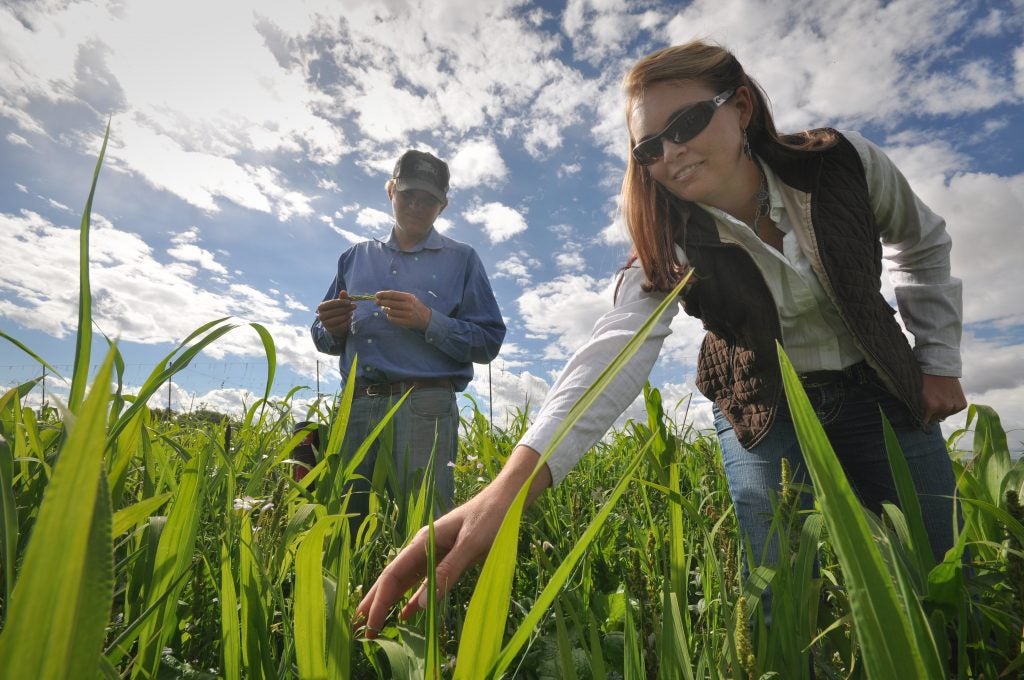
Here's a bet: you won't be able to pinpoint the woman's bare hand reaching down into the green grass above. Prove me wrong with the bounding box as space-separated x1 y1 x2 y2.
353 445 551 638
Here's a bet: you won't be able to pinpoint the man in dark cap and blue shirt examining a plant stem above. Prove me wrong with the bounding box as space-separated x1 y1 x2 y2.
311 151 505 521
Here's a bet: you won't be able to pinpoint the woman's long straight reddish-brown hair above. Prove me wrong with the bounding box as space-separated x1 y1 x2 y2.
622 41 834 291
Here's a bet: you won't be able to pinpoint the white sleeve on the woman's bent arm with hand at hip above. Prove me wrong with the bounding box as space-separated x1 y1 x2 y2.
843 132 964 377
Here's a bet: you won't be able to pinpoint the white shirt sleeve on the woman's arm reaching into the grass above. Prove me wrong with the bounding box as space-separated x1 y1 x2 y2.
519 259 679 484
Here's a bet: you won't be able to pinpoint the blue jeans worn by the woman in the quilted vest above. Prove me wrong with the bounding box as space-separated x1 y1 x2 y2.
714 369 955 564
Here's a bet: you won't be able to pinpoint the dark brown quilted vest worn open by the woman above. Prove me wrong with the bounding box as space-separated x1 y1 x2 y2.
676 134 924 449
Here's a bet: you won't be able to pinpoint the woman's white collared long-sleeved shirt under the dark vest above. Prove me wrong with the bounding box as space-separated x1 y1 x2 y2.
520 132 963 483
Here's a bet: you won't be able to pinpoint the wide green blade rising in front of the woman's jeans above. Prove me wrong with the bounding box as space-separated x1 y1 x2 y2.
778 346 942 678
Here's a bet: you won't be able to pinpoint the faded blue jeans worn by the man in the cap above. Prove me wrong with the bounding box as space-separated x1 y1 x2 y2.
341 387 459 524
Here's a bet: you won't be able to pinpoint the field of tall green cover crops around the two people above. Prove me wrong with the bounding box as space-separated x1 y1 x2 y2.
0 130 1024 680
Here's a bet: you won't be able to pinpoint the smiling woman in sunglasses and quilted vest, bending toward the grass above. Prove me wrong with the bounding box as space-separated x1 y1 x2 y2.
357 42 967 636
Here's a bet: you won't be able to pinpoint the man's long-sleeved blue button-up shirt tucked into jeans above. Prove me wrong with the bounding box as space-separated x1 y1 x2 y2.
311 229 505 391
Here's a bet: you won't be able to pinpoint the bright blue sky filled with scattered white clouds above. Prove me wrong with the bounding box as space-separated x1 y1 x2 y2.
0 0 1024 441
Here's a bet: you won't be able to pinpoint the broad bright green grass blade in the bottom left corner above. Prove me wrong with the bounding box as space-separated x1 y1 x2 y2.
0 354 114 678
